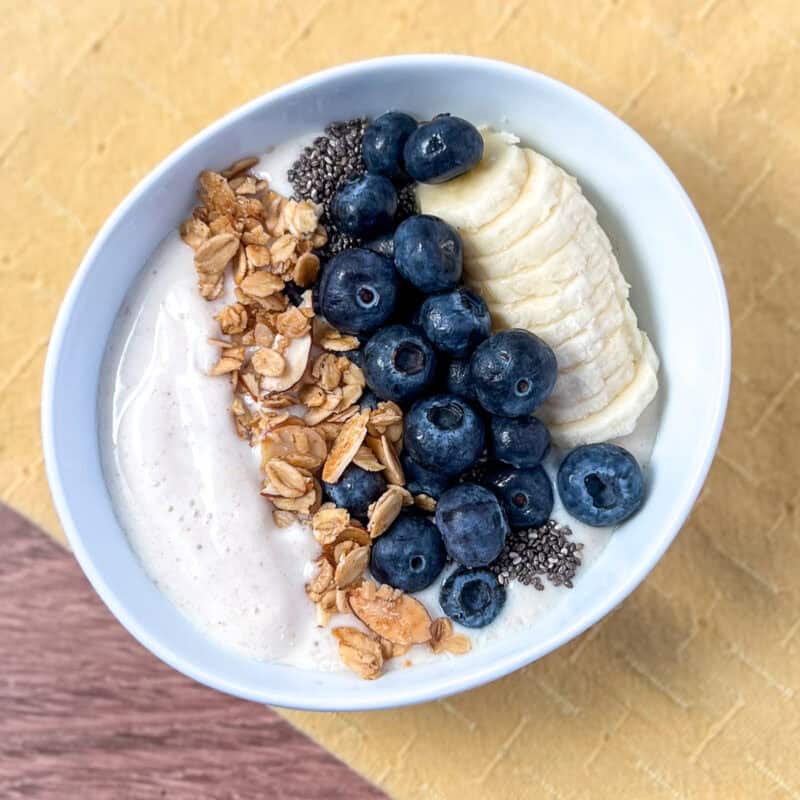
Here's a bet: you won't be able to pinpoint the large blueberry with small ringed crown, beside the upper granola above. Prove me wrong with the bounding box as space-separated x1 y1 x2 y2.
317 248 399 333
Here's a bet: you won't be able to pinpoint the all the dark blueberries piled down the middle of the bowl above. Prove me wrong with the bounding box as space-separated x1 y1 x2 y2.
314 112 641 627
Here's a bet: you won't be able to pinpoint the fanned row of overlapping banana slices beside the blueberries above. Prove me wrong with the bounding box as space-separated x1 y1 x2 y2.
418 133 658 446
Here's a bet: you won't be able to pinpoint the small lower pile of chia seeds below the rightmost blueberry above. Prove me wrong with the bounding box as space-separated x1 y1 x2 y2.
489 519 583 592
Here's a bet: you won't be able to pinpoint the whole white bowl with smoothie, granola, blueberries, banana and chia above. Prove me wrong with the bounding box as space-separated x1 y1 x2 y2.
43 56 730 710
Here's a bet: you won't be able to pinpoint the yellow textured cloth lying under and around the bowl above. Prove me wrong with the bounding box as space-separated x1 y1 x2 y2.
0 0 800 798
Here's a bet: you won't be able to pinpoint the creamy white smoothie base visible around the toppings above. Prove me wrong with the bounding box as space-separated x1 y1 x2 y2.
99 122 659 670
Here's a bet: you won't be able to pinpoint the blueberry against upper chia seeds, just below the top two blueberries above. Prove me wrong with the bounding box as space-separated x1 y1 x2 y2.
331 175 397 237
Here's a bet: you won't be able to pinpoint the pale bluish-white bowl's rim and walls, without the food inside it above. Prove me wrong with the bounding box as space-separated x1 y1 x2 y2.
42 56 730 711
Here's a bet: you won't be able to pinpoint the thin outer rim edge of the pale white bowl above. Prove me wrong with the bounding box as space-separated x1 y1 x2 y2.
41 54 731 711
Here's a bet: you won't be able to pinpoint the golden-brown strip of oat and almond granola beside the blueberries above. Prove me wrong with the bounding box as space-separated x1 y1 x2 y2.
180 158 470 679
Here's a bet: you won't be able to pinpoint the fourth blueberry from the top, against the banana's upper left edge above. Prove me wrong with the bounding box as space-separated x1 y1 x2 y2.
394 214 464 294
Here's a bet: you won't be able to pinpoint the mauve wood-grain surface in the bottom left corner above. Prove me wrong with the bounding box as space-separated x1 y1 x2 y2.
0 506 384 800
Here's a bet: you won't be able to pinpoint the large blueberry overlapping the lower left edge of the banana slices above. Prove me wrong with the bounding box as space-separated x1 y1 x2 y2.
470 328 557 417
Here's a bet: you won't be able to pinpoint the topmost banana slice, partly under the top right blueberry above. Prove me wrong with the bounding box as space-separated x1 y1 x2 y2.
417 130 528 231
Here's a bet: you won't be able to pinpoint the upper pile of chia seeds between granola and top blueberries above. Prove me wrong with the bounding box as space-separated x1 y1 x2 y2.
287 117 417 258
